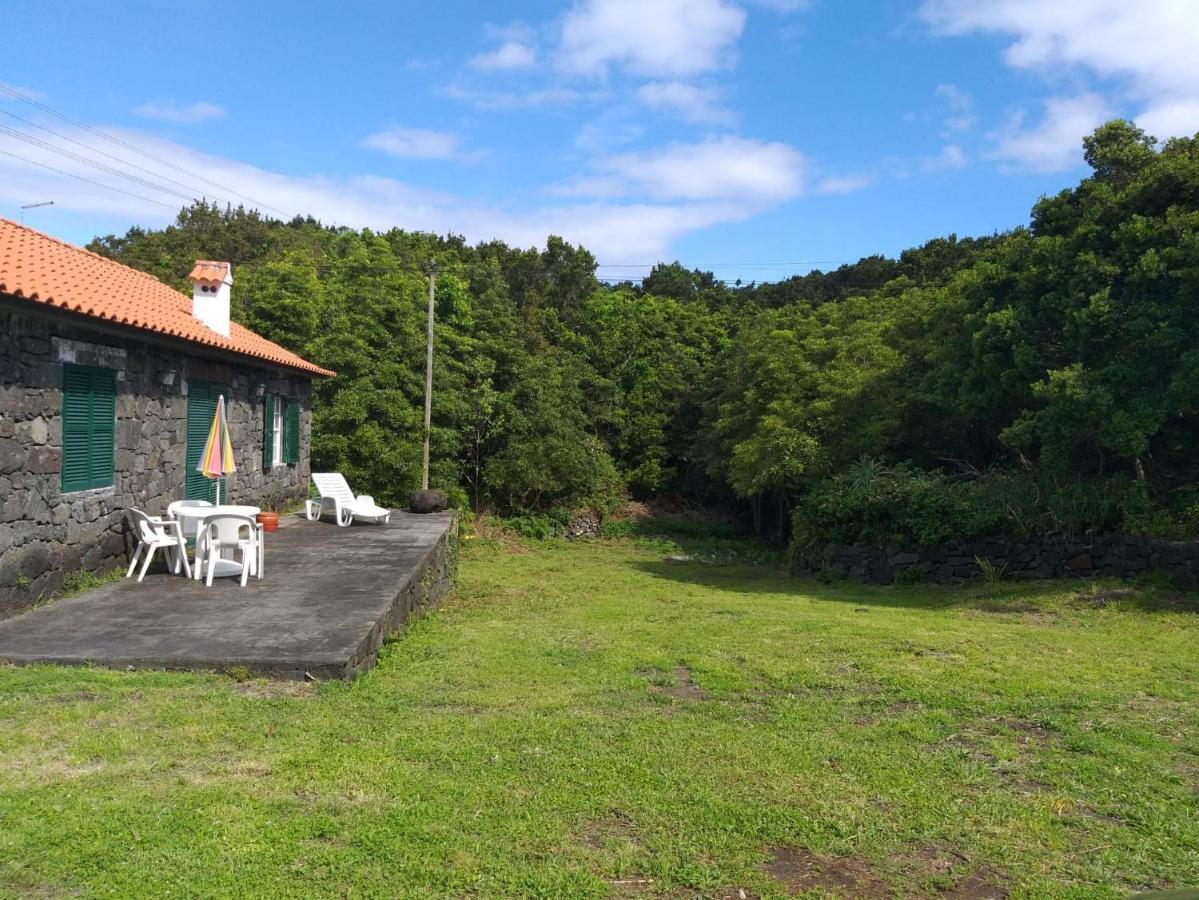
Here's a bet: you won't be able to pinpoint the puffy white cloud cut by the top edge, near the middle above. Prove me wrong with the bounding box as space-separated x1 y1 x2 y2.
559 0 746 78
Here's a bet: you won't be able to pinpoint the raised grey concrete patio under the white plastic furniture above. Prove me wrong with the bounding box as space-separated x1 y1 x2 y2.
0 512 456 681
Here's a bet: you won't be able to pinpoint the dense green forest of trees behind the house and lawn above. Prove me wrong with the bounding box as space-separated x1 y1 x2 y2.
90 121 1199 543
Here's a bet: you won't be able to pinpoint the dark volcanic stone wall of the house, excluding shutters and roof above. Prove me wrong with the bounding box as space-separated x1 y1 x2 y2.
0 308 312 617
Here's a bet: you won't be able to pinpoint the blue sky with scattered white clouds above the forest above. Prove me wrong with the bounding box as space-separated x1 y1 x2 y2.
0 0 1199 282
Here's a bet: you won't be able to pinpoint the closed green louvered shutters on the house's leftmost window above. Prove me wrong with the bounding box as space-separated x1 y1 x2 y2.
62 364 116 493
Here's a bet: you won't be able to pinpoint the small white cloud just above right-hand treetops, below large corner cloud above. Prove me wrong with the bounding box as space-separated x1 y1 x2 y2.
992 93 1111 173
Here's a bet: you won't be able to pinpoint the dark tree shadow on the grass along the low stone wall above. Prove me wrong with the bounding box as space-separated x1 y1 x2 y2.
632 560 1199 614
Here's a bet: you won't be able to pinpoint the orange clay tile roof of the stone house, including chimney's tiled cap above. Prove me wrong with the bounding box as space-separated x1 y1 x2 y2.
0 218 335 375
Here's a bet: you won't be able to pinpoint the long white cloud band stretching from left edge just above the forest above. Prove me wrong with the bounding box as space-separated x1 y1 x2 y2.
0 121 802 261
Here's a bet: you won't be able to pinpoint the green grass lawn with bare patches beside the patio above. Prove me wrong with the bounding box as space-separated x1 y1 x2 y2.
0 532 1199 898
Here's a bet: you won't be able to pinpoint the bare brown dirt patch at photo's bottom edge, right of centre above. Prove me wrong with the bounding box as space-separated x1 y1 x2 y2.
765 845 1008 900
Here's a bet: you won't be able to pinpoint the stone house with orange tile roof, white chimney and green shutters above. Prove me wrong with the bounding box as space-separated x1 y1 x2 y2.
0 218 333 617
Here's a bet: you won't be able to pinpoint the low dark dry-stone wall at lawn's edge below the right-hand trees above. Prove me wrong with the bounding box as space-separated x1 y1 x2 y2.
793 534 1199 588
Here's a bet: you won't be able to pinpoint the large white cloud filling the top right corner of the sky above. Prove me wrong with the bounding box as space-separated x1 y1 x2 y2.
921 0 1199 138
